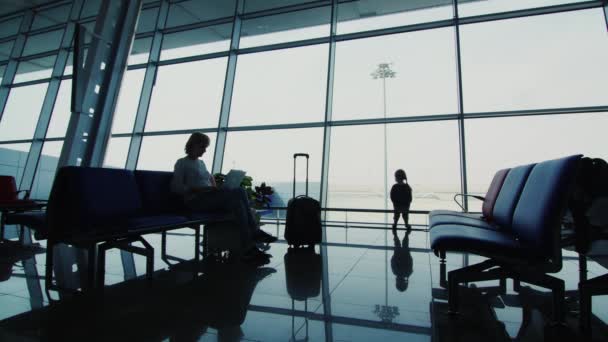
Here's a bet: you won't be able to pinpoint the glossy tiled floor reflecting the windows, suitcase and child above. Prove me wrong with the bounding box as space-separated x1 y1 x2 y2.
0 225 608 342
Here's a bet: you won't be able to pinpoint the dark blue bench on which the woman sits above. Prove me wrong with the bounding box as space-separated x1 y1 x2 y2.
44 166 233 292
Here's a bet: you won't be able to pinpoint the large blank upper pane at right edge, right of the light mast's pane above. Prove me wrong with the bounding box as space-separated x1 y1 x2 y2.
460 9 608 113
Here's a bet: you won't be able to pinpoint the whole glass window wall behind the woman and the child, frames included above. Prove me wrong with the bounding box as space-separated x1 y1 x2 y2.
0 0 608 215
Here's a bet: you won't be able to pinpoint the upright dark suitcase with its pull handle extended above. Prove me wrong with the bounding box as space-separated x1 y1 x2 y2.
285 153 321 246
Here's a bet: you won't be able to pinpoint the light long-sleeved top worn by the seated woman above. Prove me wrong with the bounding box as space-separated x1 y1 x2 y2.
171 157 211 197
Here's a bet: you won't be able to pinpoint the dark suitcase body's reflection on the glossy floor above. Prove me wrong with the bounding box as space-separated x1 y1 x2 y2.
283 248 322 301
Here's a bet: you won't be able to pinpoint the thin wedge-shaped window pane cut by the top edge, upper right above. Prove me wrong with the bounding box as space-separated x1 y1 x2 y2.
458 0 586 17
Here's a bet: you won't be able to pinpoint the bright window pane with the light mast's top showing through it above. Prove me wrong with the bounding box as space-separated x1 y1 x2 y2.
332 28 458 120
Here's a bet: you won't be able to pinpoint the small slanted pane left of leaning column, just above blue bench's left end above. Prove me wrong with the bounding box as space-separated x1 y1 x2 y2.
30 141 63 199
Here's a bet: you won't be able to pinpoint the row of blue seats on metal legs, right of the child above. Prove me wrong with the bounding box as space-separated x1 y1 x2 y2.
429 155 581 322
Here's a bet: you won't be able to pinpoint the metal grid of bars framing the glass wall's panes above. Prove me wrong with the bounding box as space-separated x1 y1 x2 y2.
0 0 608 208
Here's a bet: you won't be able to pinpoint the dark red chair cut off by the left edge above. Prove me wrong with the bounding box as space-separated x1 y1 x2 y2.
0 176 44 241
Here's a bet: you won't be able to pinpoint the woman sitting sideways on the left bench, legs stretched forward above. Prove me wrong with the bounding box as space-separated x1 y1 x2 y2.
171 132 277 260
